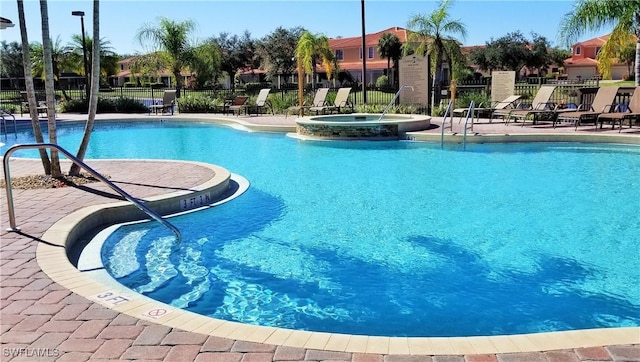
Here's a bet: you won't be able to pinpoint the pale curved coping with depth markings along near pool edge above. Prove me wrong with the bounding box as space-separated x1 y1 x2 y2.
36 153 640 355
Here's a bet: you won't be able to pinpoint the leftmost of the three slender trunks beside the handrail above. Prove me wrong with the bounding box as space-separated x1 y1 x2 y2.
18 0 51 175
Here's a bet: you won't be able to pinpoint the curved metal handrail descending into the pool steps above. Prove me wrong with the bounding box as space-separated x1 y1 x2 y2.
3 143 182 243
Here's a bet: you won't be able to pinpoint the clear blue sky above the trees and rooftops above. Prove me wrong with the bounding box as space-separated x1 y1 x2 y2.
0 0 611 54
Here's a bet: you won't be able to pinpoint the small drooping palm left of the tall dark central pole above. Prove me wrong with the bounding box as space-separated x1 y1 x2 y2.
296 31 334 89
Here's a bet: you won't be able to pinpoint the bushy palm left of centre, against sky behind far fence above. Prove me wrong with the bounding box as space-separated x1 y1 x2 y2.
136 18 196 97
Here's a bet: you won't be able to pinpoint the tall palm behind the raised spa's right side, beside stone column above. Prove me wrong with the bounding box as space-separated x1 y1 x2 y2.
404 0 467 110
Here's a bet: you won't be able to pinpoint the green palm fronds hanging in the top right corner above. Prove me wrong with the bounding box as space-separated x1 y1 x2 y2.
560 0 640 86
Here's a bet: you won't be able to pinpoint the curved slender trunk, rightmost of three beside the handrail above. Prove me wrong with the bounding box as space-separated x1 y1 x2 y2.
69 0 101 176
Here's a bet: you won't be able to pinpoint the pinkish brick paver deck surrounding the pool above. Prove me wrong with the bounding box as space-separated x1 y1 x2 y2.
0 115 640 362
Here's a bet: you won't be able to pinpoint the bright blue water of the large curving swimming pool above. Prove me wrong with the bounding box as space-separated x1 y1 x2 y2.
2 122 640 336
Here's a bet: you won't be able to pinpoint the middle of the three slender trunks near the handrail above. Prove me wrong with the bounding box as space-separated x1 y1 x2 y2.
40 0 62 177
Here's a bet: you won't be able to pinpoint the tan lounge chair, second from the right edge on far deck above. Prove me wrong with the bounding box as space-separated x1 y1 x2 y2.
553 86 620 130
